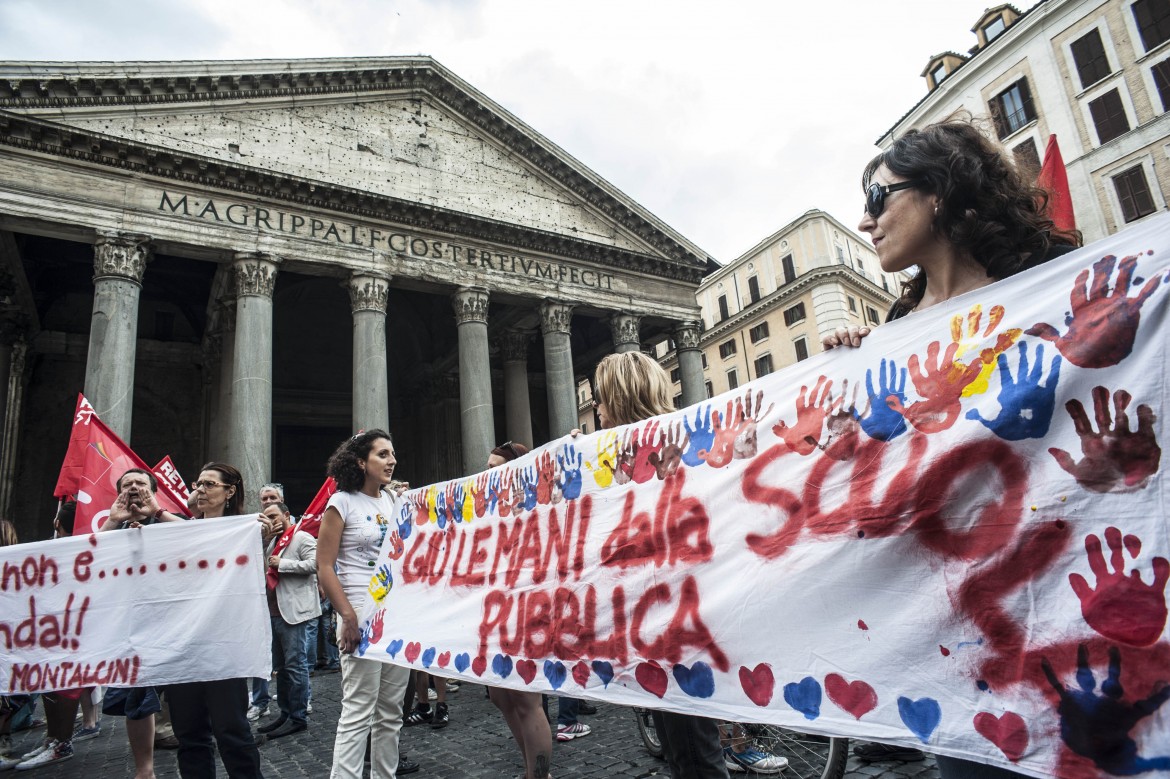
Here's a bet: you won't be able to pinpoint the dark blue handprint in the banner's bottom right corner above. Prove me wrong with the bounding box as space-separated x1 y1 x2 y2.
1040 643 1170 777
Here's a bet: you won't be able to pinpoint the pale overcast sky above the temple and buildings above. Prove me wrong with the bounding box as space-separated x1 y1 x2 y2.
0 0 1033 263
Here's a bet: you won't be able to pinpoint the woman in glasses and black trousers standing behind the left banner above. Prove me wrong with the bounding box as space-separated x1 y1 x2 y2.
166 462 263 779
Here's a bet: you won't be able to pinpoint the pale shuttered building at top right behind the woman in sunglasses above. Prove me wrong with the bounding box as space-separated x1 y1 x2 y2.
878 0 1170 241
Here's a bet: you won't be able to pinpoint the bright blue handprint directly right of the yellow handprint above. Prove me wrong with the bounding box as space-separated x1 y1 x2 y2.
966 340 1061 441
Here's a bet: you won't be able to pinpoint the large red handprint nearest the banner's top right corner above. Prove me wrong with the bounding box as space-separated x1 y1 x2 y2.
1027 254 1162 367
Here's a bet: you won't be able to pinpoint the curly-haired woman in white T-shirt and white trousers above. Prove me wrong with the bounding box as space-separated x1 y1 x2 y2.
317 430 410 779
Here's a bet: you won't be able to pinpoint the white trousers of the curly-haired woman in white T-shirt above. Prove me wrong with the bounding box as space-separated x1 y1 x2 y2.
329 655 411 779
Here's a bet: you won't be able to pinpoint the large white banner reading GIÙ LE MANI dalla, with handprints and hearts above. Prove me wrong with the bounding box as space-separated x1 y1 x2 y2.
359 218 1170 777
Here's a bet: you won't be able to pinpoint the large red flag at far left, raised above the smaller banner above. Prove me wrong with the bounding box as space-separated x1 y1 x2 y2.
53 394 190 536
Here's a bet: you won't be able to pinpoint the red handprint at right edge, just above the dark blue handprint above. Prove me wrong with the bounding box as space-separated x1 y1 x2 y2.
1068 528 1170 647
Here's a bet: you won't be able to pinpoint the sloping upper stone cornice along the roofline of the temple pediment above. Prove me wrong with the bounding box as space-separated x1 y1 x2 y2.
0 57 707 277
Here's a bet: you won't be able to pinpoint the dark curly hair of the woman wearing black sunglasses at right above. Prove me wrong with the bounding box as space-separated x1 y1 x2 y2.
861 116 1081 310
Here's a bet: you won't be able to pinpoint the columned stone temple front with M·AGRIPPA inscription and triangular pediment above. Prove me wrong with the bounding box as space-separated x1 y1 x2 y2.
0 57 711 528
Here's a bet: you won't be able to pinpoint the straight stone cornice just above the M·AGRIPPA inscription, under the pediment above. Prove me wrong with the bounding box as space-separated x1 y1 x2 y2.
0 111 707 284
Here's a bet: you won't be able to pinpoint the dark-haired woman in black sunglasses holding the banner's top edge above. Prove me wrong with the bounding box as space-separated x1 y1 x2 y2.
821 119 1080 349
